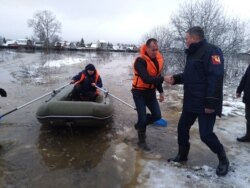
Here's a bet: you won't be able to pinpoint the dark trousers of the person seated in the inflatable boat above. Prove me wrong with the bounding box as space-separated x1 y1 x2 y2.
71 84 97 101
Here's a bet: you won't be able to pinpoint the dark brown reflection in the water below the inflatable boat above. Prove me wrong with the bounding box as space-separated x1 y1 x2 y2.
38 125 109 171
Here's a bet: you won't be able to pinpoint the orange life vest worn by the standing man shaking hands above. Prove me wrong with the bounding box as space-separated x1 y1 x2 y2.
132 44 164 90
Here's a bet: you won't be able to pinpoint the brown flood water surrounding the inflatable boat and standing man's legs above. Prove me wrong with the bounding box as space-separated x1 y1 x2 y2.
0 50 250 188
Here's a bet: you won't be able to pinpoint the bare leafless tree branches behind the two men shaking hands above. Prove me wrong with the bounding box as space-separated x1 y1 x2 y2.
143 0 250 82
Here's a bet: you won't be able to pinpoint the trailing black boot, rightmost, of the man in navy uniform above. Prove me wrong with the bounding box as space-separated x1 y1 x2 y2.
216 149 229 176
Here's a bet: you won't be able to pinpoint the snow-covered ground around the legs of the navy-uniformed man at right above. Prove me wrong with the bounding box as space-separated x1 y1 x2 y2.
137 88 250 188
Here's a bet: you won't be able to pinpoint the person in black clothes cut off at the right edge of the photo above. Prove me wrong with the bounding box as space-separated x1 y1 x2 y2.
236 65 250 142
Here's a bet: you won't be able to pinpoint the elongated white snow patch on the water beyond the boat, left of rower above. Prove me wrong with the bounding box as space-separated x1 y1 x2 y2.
44 57 86 67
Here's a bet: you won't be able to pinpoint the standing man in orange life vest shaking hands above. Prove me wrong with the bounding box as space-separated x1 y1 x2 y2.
132 38 167 151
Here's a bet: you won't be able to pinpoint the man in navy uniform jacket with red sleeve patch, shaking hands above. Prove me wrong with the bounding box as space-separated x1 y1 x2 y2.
168 27 229 176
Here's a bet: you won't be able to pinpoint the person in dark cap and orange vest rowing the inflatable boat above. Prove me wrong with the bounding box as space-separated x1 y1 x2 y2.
70 64 102 101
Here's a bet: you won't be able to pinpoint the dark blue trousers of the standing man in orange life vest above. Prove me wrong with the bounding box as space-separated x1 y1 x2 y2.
132 91 161 131
